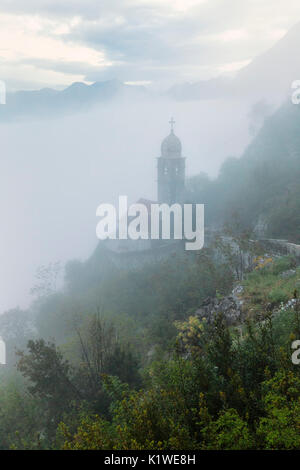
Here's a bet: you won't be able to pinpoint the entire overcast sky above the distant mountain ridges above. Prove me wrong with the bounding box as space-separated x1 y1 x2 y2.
0 0 300 90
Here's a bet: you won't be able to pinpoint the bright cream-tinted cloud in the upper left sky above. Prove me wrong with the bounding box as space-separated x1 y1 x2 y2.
0 13 110 90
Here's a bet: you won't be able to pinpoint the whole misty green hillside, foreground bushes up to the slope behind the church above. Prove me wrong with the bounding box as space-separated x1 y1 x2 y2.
0 55 300 450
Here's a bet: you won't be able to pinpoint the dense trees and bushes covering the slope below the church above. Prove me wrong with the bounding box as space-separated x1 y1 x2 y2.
0 251 300 449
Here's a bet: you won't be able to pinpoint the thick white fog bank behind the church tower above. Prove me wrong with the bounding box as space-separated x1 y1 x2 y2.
0 91 258 312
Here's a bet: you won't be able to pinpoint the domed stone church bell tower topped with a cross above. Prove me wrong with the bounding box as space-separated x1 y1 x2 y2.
157 118 185 204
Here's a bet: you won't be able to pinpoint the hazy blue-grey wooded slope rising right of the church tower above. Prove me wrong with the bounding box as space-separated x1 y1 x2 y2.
187 98 300 242
